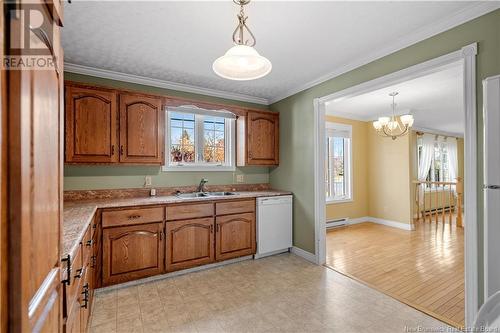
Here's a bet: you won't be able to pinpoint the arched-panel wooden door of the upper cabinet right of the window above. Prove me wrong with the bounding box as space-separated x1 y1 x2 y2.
247 111 279 165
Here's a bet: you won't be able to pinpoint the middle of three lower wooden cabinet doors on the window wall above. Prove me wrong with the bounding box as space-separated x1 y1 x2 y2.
166 217 214 272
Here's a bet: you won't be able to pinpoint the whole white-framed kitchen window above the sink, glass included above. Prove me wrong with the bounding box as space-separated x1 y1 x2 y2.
163 106 236 171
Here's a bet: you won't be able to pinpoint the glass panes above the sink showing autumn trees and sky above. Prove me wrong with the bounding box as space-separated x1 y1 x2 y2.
170 112 226 163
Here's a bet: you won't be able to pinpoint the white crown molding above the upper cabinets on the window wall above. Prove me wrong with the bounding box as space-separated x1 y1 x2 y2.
64 62 269 105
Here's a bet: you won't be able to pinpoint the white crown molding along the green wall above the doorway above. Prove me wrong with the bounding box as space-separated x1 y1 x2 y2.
269 1 500 104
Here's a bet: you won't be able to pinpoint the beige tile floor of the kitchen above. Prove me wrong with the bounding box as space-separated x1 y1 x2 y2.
90 254 454 333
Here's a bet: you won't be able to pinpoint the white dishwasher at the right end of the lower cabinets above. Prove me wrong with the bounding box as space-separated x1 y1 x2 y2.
254 195 293 259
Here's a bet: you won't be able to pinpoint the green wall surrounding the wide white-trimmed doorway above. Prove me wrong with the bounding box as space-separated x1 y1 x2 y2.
270 10 500 296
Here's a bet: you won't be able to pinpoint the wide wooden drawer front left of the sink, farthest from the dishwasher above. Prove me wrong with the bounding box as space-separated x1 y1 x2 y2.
102 207 163 228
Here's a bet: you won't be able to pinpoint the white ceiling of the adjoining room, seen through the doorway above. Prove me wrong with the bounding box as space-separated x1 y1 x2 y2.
326 64 465 136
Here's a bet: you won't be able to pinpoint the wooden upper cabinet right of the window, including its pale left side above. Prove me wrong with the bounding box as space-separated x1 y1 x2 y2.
237 111 279 166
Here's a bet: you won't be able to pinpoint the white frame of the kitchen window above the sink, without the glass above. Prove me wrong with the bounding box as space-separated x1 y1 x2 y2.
162 107 236 172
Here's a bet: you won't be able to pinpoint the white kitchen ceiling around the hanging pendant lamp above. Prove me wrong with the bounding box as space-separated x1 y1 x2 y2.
62 1 492 101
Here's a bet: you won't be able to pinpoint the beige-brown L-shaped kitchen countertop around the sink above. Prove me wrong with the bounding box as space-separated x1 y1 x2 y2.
62 190 292 257
